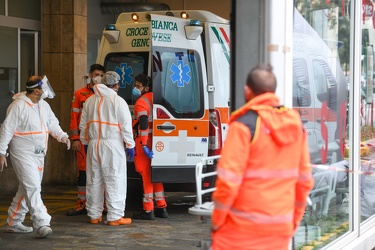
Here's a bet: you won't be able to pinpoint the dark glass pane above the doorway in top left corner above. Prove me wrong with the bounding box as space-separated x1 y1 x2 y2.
8 0 41 21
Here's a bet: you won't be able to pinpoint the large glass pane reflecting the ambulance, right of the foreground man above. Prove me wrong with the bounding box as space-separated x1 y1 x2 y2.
293 0 352 249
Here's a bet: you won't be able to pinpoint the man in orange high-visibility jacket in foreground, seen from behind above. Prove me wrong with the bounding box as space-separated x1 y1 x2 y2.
212 65 313 250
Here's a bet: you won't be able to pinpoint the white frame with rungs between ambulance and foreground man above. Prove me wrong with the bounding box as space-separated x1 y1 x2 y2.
189 155 220 221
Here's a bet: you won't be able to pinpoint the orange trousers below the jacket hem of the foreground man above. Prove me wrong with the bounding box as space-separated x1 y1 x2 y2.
212 224 292 250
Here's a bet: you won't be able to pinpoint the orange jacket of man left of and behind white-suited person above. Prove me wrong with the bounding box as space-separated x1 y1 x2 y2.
70 85 94 140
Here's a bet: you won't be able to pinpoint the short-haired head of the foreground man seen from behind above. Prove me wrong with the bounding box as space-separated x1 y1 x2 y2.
246 64 277 95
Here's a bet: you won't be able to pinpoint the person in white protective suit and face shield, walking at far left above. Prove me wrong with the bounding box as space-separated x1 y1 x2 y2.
0 76 70 238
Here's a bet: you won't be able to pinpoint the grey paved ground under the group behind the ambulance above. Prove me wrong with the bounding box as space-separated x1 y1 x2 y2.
0 187 210 250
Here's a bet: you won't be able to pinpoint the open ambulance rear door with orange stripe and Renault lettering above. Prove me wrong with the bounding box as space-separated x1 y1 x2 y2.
151 15 209 183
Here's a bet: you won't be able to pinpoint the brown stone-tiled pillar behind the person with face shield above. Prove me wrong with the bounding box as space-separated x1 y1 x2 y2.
41 0 87 185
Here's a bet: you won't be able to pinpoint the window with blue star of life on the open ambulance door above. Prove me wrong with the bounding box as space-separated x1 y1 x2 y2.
153 47 204 118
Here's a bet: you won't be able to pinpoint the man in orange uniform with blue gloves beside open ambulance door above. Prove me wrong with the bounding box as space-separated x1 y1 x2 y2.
132 74 168 220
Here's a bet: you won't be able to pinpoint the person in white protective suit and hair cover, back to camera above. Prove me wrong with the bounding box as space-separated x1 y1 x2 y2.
79 71 135 226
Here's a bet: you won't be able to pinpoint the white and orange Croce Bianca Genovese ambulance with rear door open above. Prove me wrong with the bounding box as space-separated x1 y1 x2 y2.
97 10 230 186
